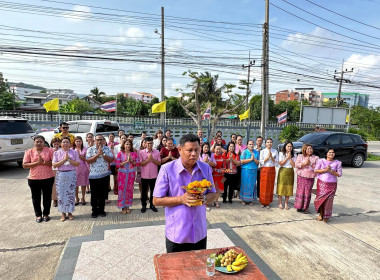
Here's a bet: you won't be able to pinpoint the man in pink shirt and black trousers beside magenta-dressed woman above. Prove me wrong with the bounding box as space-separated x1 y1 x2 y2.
139 137 161 213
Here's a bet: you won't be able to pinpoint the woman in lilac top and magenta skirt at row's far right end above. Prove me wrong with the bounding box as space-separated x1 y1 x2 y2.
314 149 342 223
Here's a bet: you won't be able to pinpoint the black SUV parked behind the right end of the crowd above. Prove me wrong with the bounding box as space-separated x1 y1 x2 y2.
278 131 368 167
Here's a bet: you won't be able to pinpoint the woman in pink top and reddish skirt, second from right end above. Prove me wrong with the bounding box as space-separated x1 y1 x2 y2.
294 144 318 214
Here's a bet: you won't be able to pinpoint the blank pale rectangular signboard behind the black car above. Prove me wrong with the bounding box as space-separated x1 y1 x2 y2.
302 106 347 125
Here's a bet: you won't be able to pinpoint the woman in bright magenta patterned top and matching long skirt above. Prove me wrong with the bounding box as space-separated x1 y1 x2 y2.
116 140 138 214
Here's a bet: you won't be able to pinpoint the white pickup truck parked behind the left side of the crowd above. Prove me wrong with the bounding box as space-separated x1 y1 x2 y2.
39 120 119 146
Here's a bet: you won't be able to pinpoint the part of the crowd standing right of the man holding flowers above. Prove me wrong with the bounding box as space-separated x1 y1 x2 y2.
198 131 342 222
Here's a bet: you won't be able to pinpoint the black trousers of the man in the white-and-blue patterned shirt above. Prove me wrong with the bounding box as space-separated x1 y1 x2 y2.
90 175 110 214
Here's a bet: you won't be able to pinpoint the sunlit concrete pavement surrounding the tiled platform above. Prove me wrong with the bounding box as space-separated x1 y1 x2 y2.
0 142 380 279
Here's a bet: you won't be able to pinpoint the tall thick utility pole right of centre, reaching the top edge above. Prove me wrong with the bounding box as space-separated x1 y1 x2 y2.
260 0 269 139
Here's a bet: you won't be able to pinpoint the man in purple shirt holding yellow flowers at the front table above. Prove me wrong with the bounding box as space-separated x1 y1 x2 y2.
153 134 216 253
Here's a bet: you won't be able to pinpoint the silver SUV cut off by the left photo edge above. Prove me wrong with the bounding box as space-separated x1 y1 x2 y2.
0 116 35 166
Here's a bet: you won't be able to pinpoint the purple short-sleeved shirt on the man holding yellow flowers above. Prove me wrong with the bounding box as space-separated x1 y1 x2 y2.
153 158 215 243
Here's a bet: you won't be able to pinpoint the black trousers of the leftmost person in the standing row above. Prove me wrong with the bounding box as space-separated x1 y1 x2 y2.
28 177 54 217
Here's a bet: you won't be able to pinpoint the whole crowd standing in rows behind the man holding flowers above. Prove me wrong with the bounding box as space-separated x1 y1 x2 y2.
23 123 342 222
